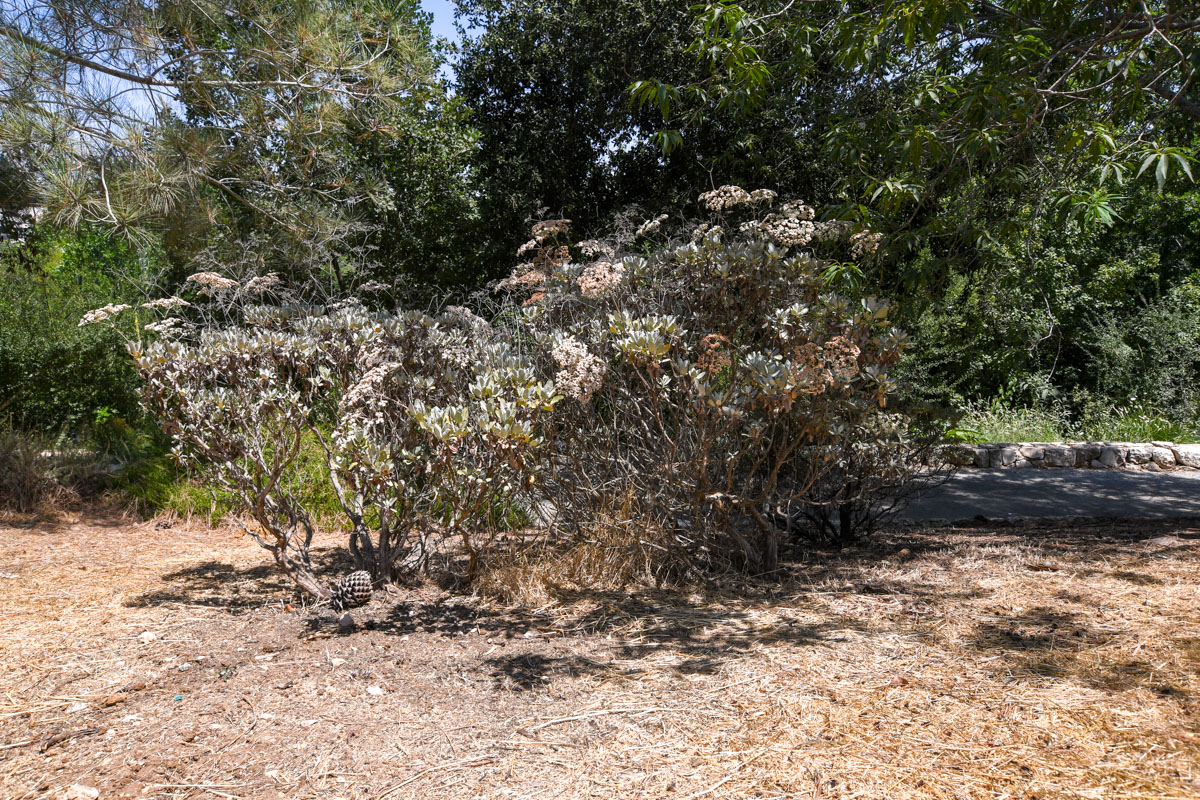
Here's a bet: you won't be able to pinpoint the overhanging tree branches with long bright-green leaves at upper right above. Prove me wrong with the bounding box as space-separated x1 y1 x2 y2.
632 0 1200 283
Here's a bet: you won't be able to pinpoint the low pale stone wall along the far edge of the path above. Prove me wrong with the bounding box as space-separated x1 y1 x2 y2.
935 441 1200 473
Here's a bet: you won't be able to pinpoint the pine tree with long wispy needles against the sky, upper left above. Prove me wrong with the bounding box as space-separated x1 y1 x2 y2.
0 0 463 281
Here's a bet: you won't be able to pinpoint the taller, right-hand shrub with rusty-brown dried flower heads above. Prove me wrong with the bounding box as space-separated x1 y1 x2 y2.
496 186 912 569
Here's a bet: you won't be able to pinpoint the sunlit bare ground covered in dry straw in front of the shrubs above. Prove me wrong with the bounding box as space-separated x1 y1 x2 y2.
0 512 1200 800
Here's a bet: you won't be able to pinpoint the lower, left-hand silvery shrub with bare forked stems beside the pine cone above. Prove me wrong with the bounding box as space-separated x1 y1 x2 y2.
96 273 559 599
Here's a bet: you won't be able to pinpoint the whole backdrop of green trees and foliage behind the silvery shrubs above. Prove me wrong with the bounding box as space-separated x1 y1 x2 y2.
0 0 1200 527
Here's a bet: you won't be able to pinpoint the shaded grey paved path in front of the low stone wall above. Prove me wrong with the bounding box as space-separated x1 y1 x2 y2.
900 469 1200 521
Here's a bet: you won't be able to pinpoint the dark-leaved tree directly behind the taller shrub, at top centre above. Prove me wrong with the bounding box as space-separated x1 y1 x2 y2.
456 0 832 276
